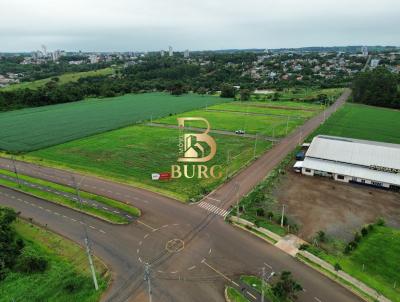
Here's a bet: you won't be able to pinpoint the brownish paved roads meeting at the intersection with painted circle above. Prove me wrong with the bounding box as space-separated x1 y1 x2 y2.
0 88 361 302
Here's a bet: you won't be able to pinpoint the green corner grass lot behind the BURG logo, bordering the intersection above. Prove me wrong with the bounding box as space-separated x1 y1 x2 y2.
28 125 271 201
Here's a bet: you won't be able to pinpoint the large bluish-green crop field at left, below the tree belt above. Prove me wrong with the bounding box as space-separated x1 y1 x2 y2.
0 93 229 152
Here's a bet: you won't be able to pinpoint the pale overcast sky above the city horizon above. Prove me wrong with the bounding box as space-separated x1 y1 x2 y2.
0 0 400 52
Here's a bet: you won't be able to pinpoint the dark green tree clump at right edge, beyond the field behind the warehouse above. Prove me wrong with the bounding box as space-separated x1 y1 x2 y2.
352 67 400 108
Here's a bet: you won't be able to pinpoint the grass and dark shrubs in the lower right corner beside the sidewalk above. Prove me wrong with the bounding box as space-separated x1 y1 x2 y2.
301 219 400 302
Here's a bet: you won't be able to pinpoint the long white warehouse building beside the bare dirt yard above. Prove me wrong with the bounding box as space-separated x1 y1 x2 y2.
294 135 400 190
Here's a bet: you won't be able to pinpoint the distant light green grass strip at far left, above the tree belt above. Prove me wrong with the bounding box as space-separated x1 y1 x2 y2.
0 67 115 91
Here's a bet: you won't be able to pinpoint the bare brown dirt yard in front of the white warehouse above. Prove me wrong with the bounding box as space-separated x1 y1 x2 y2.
275 171 400 240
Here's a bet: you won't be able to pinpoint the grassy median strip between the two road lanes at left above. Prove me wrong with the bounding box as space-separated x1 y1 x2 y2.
0 169 140 223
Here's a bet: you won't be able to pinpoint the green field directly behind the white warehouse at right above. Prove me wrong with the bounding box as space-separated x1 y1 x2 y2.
312 103 400 144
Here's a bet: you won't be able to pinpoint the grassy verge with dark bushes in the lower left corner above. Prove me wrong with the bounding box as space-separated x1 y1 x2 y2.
0 208 110 302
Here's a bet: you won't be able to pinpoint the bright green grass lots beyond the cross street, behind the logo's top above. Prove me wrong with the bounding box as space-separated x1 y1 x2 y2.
155 110 305 137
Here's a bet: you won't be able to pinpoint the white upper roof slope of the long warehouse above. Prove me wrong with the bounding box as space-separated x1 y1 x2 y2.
306 135 400 171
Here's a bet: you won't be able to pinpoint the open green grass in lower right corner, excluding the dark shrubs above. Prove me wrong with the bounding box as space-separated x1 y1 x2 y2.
311 226 400 302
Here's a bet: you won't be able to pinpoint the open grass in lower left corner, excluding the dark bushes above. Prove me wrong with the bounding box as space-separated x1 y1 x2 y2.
0 220 109 302
